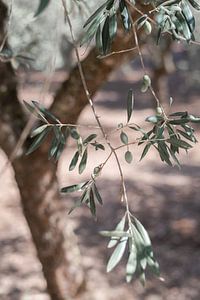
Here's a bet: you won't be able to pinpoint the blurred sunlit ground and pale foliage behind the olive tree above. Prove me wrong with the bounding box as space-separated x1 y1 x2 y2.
0 0 200 300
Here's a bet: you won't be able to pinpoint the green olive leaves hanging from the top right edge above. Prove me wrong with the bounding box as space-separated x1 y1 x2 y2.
81 0 200 56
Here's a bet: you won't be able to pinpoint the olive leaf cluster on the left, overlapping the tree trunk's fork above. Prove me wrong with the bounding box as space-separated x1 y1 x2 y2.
24 101 105 163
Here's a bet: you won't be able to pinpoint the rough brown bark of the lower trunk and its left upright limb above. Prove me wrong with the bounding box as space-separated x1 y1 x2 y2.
0 2 85 300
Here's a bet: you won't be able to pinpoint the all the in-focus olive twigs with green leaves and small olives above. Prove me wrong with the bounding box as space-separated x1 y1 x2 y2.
24 0 200 285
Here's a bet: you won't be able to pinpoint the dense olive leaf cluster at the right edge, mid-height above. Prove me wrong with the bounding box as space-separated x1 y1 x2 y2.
134 112 200 166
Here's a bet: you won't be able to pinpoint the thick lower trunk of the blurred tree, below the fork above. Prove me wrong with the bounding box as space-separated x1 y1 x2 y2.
13 149 85 300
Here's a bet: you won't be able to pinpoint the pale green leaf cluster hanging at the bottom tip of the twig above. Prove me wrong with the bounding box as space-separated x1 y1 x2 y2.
100 214 160 285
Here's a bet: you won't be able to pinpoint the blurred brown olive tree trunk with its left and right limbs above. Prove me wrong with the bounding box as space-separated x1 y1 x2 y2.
0 1 155 300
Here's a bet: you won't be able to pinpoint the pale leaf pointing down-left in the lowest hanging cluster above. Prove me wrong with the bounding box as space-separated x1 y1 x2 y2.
107 237 128 272
